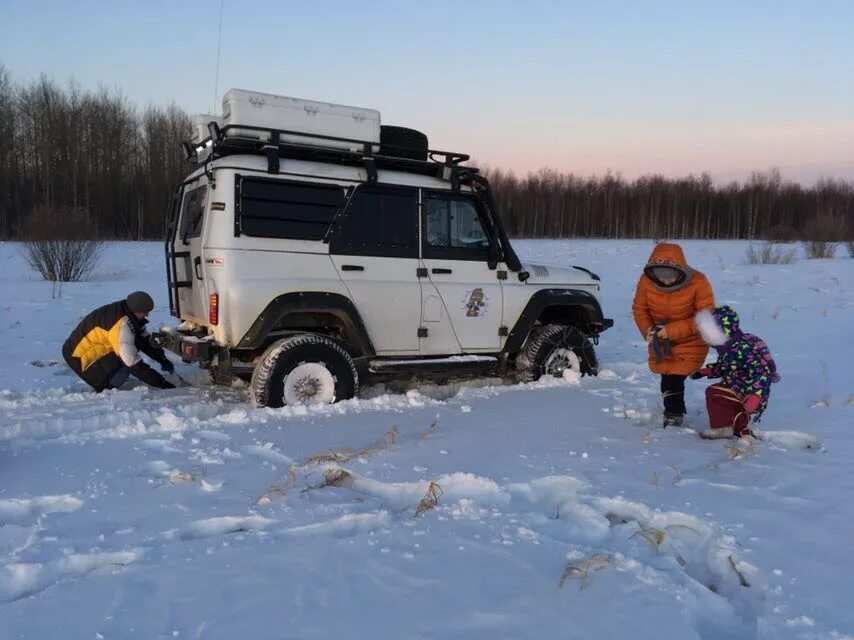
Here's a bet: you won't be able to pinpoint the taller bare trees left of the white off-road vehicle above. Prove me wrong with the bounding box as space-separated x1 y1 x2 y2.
0 65 191 240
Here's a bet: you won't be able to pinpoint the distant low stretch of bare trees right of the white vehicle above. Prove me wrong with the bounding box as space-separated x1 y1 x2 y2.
488 169 854 241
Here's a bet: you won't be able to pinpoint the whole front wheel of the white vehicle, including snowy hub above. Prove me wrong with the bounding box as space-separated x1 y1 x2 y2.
516 324 599 382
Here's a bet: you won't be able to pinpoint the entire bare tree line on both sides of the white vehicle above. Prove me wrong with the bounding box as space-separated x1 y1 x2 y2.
0 65 854 240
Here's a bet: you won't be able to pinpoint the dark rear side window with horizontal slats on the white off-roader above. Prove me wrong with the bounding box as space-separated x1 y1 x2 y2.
236 178 347 240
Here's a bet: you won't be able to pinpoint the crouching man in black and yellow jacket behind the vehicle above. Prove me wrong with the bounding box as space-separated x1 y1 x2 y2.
62 291 175 393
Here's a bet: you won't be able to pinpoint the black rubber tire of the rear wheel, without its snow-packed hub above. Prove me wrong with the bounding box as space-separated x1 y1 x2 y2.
254 334 359 408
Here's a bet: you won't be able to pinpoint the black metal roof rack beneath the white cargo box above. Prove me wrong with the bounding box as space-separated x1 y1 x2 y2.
182 121 477 182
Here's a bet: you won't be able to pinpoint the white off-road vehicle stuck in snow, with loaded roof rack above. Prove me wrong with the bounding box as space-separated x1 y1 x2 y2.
160 90 612 407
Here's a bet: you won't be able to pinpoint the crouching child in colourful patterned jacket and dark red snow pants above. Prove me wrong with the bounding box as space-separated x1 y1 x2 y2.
691 306 780 439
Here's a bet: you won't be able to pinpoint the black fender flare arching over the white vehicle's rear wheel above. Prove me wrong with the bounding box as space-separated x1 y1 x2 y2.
235 291 376 357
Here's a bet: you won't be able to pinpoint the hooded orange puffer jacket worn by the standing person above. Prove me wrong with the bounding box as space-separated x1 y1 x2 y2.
632 242 715 376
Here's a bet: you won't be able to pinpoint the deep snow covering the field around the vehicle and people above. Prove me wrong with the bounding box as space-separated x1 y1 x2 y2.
0 240 854 640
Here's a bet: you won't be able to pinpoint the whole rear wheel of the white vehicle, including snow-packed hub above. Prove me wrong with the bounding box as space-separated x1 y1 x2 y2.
254 334 359 408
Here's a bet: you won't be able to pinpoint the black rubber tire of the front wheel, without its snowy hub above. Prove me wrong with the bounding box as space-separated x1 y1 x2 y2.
516 324 599 382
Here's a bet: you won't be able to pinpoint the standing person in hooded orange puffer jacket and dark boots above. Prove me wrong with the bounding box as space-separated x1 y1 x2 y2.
632 242 715 427
